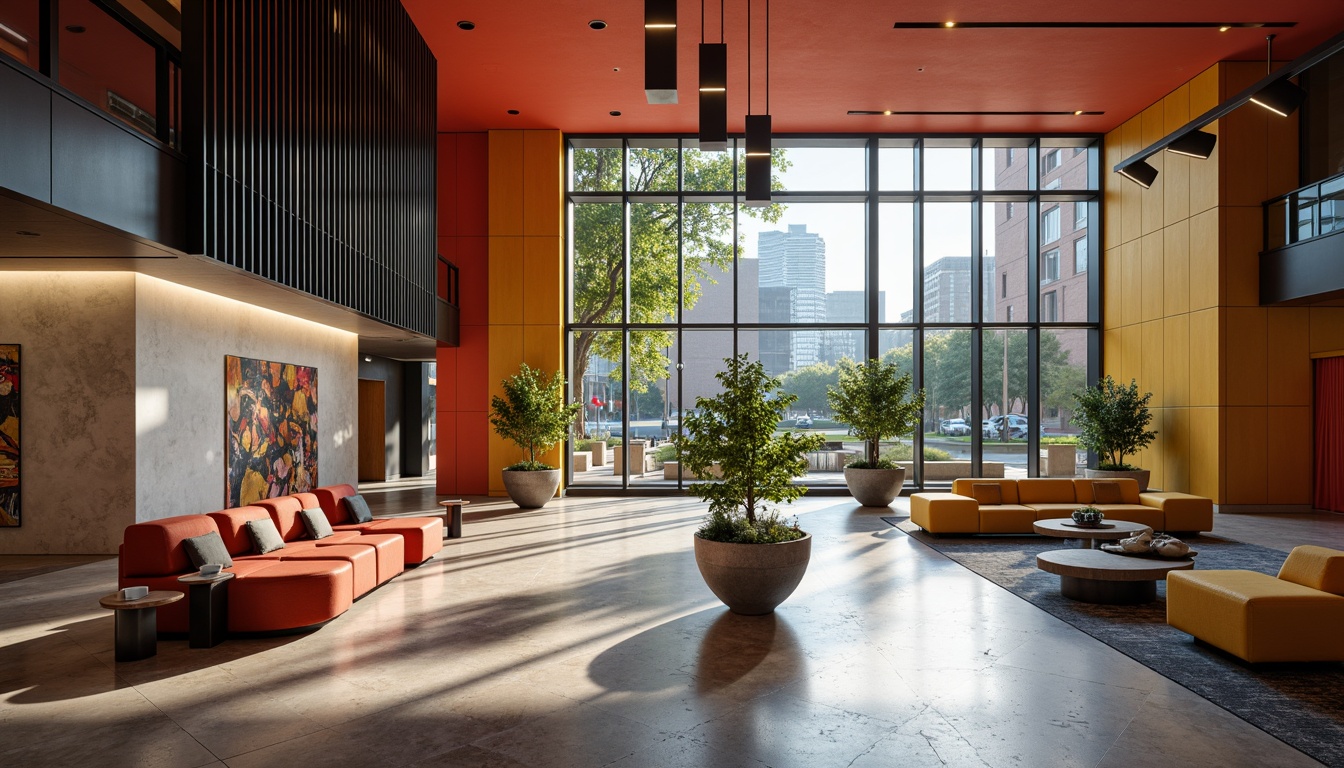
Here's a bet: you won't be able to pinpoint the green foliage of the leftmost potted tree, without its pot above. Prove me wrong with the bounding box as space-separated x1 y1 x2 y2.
491 363 583 472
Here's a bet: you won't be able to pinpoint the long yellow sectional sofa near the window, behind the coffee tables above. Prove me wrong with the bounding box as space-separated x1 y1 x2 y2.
910 477 1214 534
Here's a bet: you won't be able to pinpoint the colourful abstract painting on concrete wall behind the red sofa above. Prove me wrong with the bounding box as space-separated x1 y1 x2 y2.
224 355 317 507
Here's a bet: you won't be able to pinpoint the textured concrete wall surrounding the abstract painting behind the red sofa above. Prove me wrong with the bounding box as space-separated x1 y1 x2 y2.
135 276 359 521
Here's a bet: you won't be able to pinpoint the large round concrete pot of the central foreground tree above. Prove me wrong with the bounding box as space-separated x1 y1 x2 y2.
695 534 812 616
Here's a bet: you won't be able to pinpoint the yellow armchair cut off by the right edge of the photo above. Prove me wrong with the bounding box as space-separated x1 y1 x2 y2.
1167 546 1344 662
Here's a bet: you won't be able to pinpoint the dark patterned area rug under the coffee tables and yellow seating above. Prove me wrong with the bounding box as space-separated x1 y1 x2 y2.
883 527 1344 767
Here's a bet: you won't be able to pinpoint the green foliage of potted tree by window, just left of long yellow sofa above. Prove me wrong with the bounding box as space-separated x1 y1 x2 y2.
827 358 925 469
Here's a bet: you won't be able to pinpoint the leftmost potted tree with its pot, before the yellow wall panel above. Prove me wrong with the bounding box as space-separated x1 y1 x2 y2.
491 363 582 508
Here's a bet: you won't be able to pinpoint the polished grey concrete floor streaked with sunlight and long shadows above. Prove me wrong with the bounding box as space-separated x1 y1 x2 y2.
0 487 1344 768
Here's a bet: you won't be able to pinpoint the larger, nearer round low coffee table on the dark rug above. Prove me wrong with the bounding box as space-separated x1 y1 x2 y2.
1036 549 1195 605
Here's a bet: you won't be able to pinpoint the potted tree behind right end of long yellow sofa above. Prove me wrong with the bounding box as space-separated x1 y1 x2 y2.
1074 377 1157 491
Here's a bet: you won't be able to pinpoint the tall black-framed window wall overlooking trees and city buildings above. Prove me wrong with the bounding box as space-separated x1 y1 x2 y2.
567 136 1101 491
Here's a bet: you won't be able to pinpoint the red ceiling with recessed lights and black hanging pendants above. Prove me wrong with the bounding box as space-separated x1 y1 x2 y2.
402 0 1344 133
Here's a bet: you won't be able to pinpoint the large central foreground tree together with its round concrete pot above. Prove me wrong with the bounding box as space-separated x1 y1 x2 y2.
676 355 825 616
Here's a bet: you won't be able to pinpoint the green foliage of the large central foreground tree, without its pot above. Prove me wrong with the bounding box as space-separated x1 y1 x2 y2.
676 355 825 543
